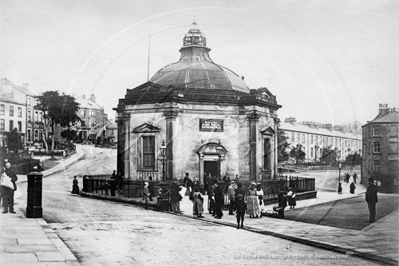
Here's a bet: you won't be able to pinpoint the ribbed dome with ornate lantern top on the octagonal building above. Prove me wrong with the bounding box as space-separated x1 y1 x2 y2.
150 21 249 93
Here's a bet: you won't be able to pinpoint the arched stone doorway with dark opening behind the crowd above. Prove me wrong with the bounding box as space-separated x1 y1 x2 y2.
197 142 227 189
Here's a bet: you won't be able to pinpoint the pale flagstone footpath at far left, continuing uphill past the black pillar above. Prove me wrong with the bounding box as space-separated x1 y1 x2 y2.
0 148 85 266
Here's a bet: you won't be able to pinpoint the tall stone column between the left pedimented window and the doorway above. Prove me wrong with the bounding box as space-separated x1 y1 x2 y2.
163 110 178 180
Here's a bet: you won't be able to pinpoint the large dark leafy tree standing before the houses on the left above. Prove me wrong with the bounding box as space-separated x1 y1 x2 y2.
35 91 80 150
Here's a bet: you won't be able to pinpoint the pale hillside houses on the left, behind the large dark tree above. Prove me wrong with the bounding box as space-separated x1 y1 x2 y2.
0 78 117 150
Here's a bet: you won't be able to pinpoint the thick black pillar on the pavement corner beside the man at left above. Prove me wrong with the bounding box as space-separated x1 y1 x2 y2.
26 172 43 218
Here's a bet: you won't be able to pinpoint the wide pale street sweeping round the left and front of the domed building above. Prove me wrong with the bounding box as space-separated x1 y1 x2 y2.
1 146 396 265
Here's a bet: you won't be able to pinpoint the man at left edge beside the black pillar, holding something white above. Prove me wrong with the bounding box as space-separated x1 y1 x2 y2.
1 162 18 213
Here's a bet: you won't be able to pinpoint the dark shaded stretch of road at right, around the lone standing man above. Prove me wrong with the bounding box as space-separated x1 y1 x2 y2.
285 194 399 230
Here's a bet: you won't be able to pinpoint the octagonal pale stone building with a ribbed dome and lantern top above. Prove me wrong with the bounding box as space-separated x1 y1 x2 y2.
114 22 281 184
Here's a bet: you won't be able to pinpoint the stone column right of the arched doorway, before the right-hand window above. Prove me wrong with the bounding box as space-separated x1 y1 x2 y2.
247 110 260 180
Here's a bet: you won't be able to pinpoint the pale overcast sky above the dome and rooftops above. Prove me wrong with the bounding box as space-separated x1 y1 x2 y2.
0 0 399 124
